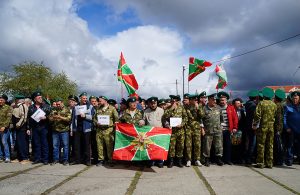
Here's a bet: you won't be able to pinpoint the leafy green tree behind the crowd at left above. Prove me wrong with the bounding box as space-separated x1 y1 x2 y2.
0 61 77 99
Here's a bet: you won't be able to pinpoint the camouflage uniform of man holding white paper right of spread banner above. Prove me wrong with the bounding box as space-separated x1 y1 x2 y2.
164 96 188 167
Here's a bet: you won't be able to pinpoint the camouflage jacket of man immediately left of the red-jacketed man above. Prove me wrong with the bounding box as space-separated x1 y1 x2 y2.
200 105 223 134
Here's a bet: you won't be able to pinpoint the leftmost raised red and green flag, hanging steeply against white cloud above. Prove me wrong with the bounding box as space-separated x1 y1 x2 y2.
118 52 139 95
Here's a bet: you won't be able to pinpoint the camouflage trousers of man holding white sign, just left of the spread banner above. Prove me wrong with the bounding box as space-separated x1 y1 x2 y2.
96 127 114 160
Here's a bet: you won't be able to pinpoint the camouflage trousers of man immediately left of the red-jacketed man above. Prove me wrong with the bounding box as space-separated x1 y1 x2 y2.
203 132 223 157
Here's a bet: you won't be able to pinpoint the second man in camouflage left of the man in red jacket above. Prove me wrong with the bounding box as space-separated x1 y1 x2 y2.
185 95 202 167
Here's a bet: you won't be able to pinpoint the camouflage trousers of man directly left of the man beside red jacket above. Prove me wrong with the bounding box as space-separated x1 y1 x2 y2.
185 129 201 160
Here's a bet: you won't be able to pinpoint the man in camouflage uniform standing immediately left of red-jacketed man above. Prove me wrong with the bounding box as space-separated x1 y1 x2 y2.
200 94 223 167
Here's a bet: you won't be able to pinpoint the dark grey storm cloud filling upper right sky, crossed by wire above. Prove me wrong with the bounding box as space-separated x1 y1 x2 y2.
104 0 300 91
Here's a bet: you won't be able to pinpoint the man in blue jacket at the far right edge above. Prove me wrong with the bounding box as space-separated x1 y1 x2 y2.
283 91 300 166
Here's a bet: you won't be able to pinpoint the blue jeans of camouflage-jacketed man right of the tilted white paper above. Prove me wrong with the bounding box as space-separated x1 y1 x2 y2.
52 131 69 161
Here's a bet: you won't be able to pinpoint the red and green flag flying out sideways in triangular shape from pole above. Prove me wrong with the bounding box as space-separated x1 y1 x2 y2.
188 57 212 81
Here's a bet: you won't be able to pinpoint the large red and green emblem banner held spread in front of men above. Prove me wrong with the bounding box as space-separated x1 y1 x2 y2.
113 123 171 161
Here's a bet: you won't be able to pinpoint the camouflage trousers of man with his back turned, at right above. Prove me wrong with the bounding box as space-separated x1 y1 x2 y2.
256 126 274 167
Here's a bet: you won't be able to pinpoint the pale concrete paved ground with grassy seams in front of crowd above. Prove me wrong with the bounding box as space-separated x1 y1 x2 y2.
0 163 300 195
